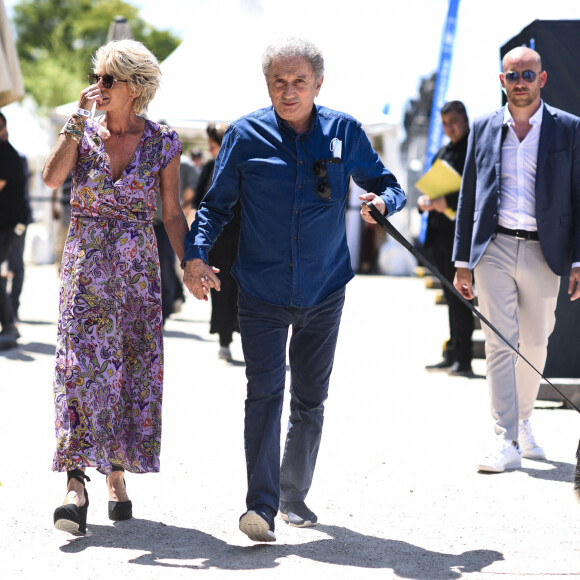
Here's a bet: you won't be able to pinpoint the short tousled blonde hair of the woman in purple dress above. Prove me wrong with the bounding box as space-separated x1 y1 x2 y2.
93 39 161 114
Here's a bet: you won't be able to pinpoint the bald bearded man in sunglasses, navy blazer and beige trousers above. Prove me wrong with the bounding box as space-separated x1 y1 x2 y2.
453 47 580 472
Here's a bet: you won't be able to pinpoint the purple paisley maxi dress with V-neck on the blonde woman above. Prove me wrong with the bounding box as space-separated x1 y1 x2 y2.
52 119 181 474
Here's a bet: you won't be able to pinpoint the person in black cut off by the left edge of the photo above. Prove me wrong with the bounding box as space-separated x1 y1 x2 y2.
0 113 29 348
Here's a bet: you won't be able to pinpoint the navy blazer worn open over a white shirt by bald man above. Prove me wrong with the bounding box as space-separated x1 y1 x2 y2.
453 105 580 276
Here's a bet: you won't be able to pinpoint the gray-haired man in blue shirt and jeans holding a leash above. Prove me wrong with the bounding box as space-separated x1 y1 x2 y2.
184 39 405 542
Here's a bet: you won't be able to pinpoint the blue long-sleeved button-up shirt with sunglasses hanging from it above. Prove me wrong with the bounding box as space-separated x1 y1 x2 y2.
185 105 406 308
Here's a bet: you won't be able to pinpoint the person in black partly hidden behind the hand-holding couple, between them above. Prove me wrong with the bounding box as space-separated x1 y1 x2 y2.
193 124 242 361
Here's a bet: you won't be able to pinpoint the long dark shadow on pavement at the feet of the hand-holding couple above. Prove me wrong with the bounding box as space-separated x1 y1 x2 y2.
61 519 504 580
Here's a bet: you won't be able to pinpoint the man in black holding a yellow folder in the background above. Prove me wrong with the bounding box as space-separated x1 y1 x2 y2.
418 101 473 376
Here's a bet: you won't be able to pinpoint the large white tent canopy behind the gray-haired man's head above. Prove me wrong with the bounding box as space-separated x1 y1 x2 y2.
56 1 398 131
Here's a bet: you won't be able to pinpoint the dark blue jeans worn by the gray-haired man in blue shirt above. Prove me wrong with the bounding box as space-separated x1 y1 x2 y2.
238 288 345 513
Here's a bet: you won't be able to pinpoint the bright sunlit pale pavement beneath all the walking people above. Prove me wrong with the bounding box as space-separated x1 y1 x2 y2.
0 266 580 580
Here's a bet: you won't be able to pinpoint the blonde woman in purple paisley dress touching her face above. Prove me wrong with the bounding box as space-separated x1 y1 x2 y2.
43 40 187 535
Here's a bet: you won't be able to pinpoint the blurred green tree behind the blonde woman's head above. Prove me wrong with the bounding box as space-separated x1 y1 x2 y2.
14 0 180 109
